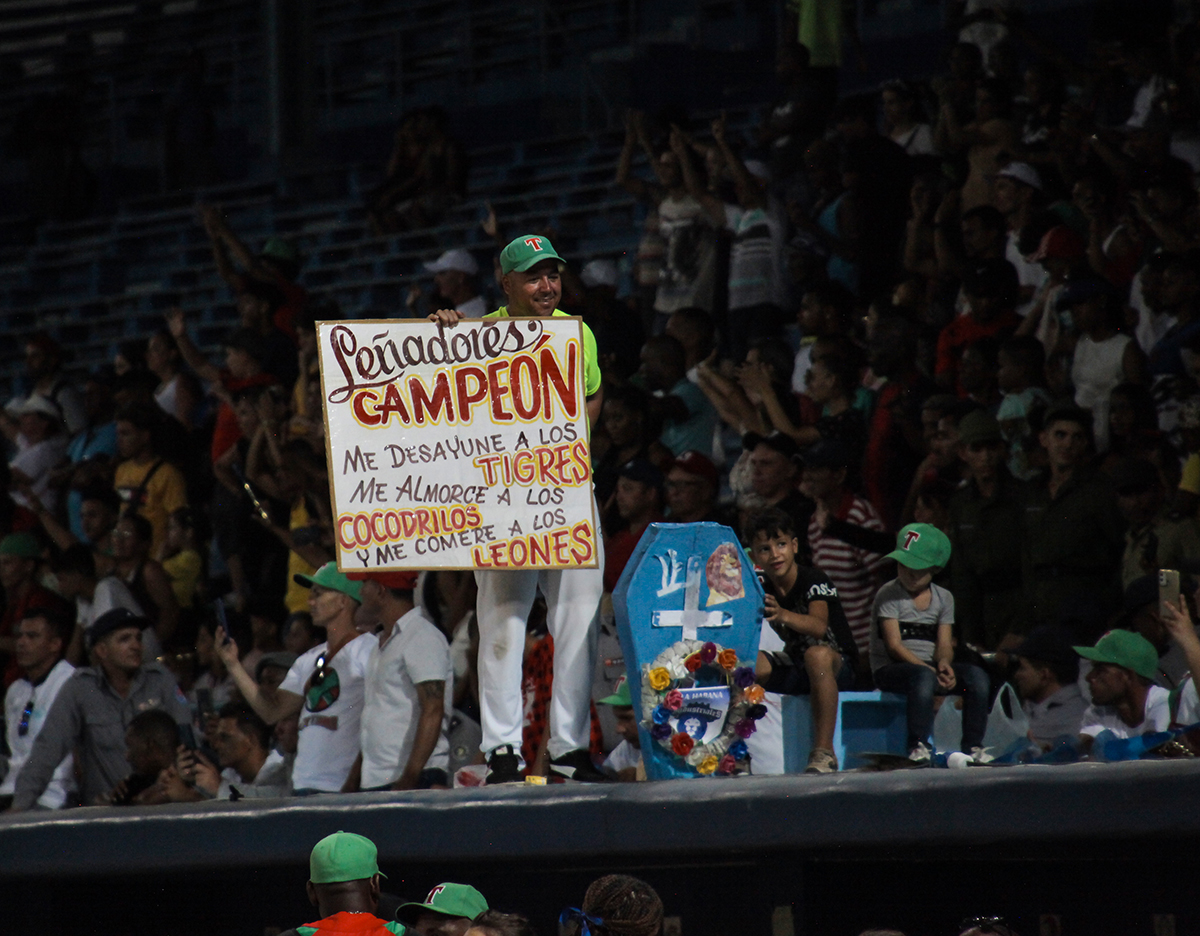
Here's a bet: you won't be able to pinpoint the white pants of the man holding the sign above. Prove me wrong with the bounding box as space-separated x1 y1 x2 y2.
475 538 604 757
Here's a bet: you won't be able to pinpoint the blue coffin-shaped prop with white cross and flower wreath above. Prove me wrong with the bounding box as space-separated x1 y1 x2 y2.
612 523 767 780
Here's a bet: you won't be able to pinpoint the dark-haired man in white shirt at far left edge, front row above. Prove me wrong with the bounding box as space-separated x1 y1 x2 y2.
0 608 74 810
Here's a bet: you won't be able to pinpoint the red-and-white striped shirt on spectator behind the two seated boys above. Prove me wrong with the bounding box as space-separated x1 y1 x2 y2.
809 491 888 650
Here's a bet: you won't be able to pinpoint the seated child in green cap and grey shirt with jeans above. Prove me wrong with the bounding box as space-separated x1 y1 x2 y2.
870 523 989 763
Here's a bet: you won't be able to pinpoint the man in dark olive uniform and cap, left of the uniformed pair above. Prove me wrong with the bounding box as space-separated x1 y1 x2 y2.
947 409 1025 650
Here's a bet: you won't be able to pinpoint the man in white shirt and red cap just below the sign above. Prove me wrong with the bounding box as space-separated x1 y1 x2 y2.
346 571 454 792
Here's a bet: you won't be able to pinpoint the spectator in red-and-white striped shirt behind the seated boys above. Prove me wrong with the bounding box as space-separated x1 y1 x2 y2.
800 442 884 649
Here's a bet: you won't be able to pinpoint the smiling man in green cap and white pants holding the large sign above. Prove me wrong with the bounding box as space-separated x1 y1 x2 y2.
430 234 608 784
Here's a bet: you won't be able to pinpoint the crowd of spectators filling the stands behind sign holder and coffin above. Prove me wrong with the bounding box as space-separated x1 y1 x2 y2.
0 0 1200 809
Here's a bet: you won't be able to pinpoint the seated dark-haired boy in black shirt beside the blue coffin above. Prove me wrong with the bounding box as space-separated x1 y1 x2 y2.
744 510 858 774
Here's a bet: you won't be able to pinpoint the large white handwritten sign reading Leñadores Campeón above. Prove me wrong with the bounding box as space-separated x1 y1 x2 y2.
317 318 599 571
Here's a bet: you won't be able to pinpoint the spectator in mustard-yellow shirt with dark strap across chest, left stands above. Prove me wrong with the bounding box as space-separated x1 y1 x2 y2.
113 404 187 552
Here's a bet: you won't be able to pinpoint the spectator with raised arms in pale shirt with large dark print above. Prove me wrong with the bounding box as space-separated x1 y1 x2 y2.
616 110 716 332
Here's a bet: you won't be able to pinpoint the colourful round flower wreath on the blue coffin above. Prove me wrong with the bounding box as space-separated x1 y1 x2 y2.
642 640 767 776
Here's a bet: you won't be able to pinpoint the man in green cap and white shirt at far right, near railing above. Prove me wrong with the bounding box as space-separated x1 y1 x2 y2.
1075 630 1195 751
